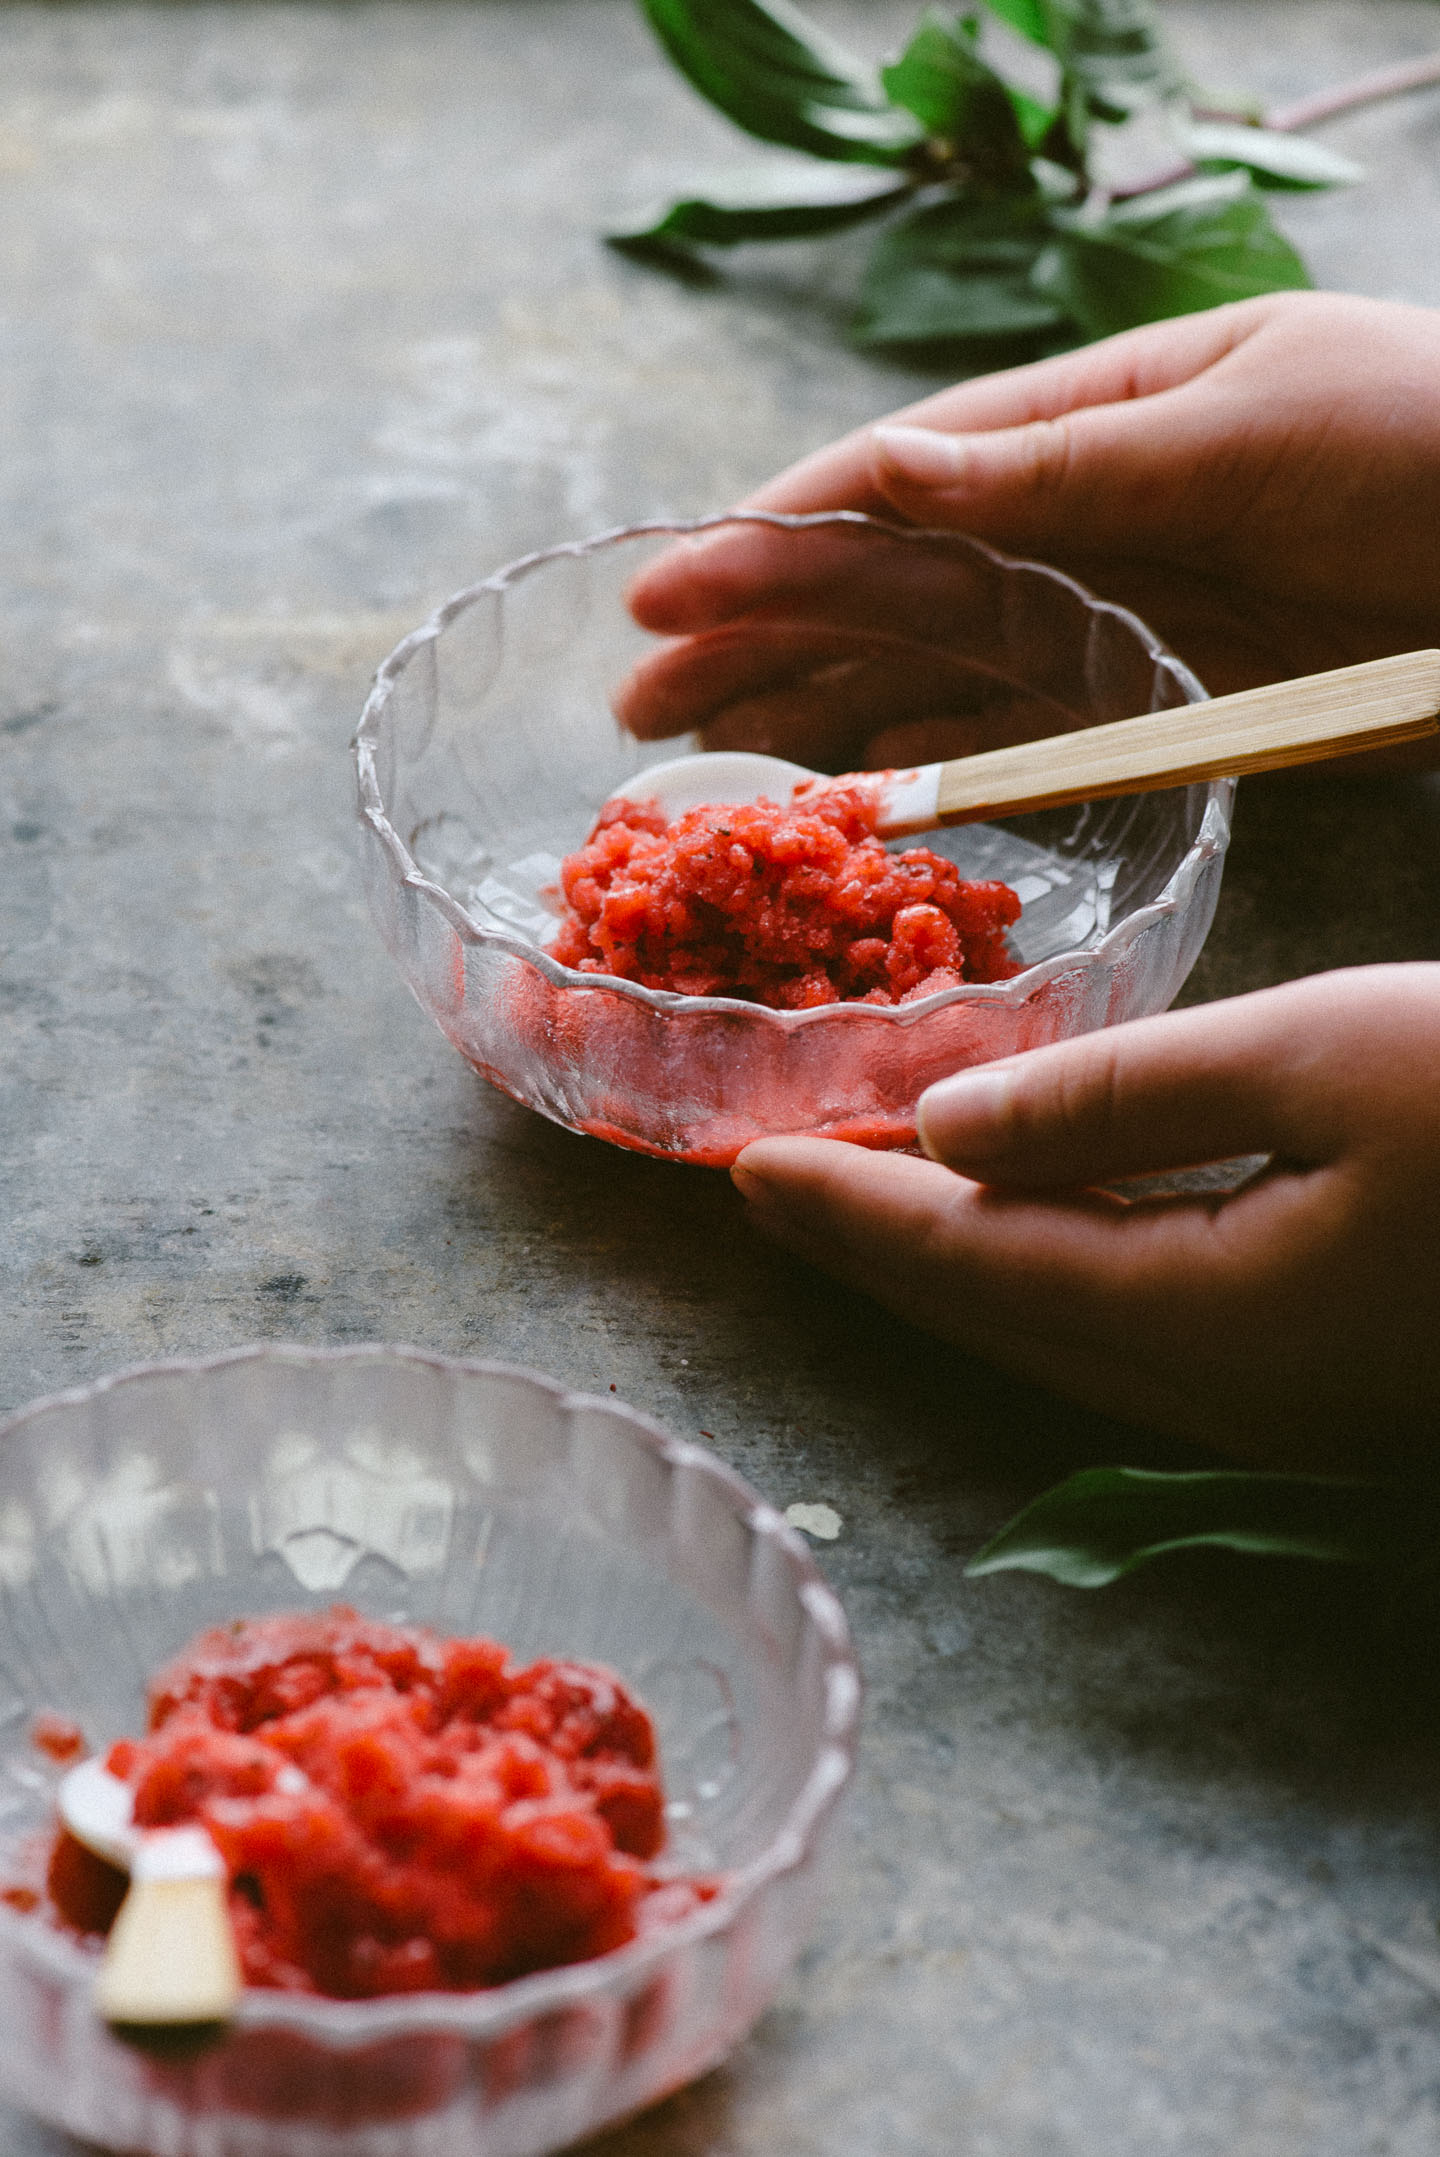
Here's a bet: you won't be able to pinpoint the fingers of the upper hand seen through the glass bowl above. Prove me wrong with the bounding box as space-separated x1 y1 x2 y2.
612 518 1103 770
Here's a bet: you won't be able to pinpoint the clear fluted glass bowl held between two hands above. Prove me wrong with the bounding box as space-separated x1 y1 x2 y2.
356 513 1233 1167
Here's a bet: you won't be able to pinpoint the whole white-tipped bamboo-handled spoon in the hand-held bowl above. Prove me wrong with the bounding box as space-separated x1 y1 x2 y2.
621 651 1440 839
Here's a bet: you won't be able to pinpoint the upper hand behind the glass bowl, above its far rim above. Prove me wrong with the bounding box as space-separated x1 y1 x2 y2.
621 293 1440 761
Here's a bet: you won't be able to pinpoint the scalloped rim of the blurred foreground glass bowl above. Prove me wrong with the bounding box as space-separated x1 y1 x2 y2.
0 1342 862 2049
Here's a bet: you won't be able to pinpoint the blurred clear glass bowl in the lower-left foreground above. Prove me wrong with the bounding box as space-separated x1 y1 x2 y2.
0 1348 860 2157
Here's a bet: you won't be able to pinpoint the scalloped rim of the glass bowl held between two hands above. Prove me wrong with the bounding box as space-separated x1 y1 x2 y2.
349 509 1235 1033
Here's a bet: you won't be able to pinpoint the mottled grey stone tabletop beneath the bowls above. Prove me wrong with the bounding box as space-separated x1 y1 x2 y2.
0 0 1440 2157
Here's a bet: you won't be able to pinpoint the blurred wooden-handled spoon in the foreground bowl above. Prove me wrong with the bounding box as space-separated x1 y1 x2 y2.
58 1760 241 2036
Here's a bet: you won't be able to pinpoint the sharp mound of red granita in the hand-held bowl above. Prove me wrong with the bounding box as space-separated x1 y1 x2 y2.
550 785 1020 1012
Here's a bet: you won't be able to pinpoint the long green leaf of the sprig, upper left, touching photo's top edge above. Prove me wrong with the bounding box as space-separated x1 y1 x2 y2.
640 0 923 164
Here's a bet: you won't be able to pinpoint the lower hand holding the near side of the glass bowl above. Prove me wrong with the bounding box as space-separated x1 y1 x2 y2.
733 964 1440 1473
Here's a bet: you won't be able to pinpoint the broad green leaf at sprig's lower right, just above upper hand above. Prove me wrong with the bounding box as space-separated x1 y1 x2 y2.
1035 173 1311 336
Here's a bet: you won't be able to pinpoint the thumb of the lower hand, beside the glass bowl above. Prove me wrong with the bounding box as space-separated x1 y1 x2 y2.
918 975 1354 1191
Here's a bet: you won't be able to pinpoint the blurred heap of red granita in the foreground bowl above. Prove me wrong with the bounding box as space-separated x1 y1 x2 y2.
47 1607 716 2000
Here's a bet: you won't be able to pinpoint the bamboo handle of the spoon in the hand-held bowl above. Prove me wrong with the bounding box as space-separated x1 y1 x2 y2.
931 651 1440 824
